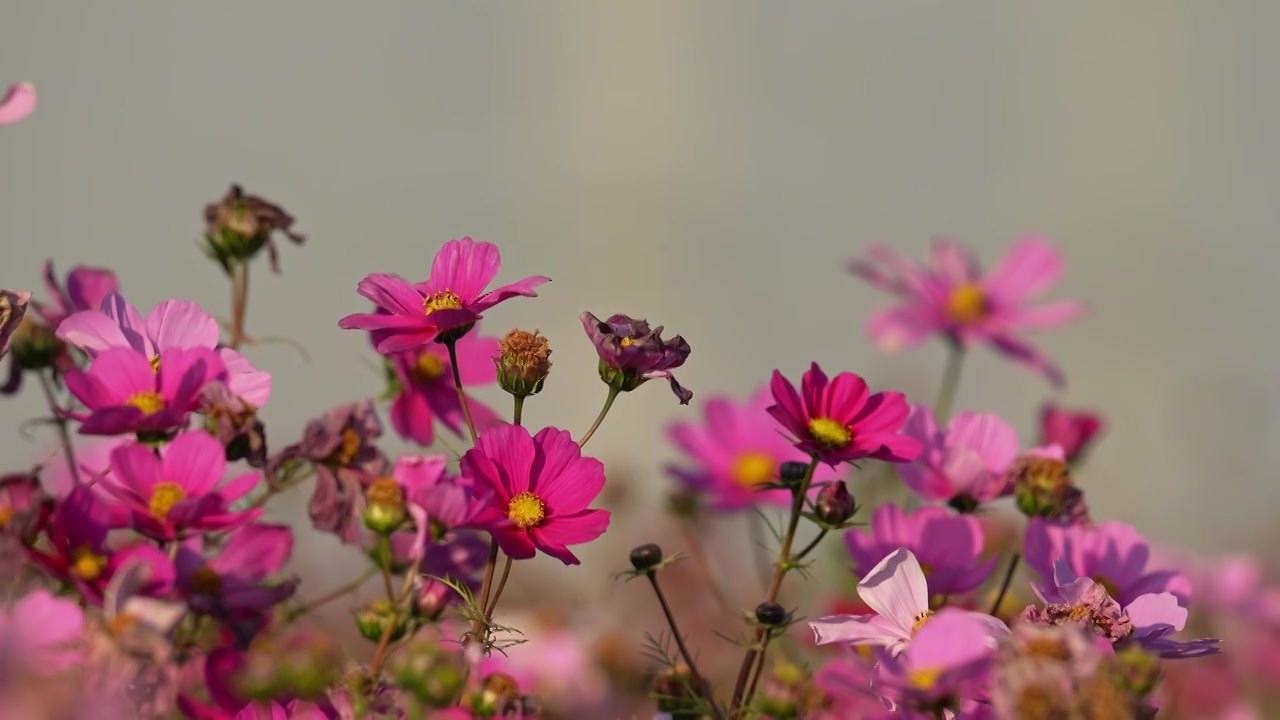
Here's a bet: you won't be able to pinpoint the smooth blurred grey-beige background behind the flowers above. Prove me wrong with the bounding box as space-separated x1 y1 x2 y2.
0 0 1280 614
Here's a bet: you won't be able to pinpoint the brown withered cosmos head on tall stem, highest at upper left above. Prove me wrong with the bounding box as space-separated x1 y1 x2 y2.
205 184 306 273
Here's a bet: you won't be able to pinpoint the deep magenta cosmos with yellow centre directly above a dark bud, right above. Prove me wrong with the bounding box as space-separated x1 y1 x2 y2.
768 363 922 466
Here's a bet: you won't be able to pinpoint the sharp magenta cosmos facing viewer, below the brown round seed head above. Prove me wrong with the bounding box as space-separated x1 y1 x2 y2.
462 424 609 565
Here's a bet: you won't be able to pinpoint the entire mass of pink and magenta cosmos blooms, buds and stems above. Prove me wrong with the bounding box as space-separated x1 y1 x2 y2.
0 79 1280 720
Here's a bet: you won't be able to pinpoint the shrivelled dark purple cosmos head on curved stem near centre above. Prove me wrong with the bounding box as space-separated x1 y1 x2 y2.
581 313 694 405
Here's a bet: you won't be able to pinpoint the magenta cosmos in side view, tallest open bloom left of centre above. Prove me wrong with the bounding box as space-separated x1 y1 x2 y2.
338 237 550 353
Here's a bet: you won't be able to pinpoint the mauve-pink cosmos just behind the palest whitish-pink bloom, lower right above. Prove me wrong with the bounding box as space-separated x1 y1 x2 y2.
845 505 996 594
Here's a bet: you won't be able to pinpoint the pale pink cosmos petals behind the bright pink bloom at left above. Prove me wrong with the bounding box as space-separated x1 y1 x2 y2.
58 292 271 407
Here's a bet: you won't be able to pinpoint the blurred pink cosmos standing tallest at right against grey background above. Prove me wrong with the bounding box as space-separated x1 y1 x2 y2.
849 237 1084 384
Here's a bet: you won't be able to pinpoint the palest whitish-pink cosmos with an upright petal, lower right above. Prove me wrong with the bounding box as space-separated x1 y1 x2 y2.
809 547 1009 656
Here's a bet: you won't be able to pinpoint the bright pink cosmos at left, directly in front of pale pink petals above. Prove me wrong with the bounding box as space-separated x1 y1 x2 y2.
67 348 227 435
